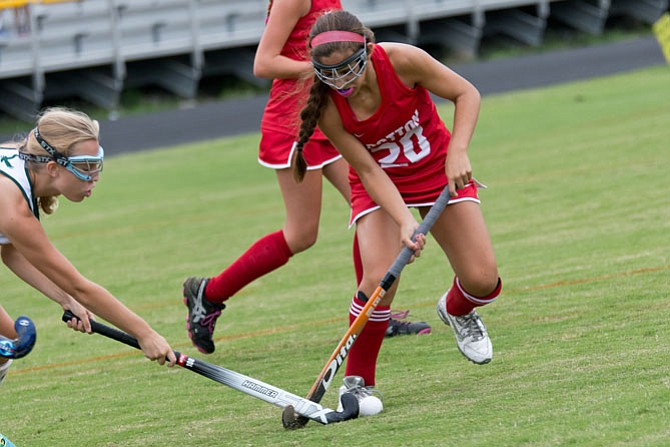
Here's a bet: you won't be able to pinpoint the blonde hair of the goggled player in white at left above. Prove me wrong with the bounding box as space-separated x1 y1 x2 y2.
19 107 100 214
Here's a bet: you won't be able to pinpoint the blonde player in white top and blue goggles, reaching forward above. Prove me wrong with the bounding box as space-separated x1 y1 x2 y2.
0 108 176 380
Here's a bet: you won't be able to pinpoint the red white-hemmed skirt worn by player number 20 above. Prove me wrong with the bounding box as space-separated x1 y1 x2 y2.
349 177 480 227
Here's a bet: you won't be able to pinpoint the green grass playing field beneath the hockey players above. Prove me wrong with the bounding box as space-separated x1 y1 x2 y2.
0 67 670 447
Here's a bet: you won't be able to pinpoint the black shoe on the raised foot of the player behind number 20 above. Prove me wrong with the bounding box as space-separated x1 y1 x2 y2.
184 277 226 354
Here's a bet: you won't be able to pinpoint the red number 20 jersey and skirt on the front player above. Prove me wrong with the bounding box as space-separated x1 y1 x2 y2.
330 45 477 222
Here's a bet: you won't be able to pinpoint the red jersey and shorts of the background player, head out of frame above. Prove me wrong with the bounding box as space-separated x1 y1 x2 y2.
259 0 342 168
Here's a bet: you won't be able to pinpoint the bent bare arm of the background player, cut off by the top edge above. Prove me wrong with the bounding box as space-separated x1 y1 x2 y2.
254 0 312 79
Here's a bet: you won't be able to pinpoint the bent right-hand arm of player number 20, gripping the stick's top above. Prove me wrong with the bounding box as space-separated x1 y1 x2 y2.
383 43 481 196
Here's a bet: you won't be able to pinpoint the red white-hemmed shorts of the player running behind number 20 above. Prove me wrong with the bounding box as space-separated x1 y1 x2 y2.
258 129 342 170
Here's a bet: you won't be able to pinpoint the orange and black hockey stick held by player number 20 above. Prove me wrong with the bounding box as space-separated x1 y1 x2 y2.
282 186 450 430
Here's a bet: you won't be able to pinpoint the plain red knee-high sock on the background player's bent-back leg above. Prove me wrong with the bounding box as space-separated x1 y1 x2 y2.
205 230 293 303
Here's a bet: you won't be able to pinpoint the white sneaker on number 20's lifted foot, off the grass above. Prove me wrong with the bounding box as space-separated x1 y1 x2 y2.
437 293 493 365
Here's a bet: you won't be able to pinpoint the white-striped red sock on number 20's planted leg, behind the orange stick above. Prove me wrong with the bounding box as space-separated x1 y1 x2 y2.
345 297 391 386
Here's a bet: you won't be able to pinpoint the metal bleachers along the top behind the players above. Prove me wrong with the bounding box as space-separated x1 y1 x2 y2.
0 0 668 119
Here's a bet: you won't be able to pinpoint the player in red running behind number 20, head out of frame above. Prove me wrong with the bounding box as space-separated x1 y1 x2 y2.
183 0 430 354
